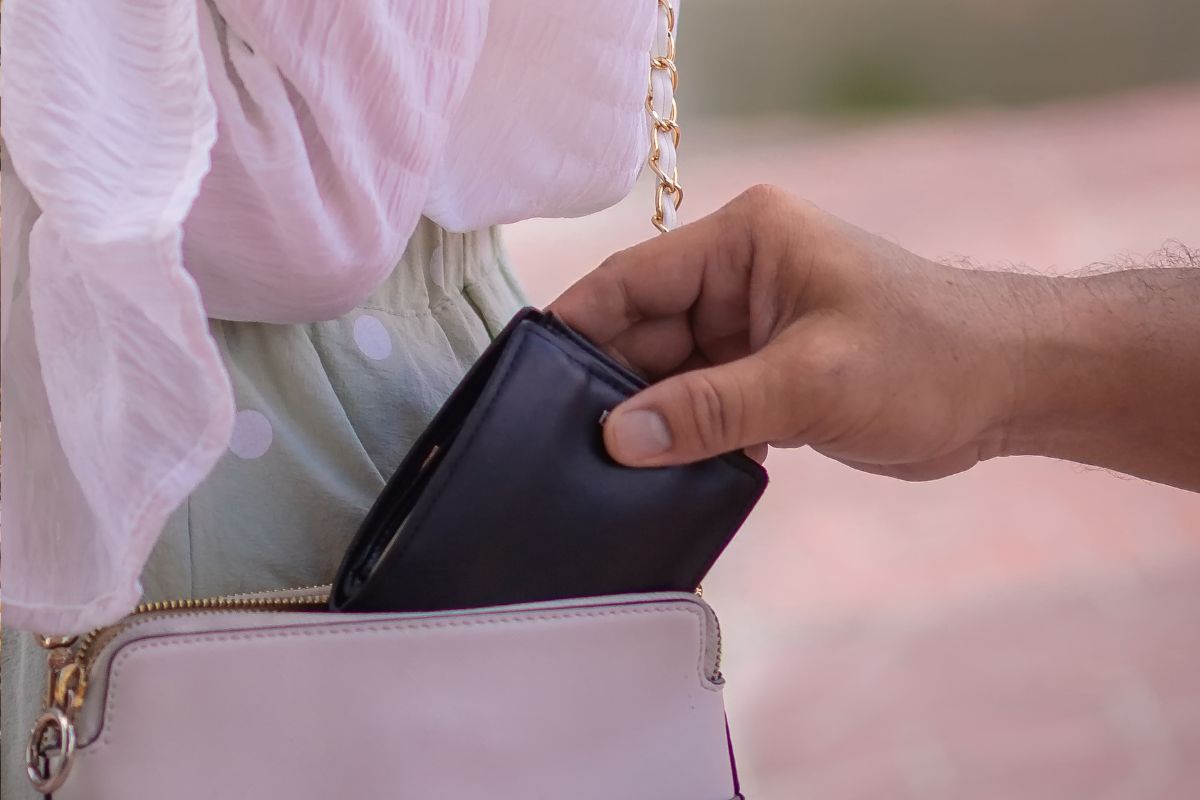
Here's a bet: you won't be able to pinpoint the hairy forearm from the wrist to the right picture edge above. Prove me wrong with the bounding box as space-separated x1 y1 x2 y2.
1004 267 1200 489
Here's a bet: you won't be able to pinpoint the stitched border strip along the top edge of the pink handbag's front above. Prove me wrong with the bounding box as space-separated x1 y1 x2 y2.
91 603 725 754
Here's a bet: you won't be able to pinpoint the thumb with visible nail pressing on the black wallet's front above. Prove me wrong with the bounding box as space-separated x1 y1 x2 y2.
604 348 791 467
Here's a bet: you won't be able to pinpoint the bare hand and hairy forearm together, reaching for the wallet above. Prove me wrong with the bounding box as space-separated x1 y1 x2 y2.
551 186 1200 491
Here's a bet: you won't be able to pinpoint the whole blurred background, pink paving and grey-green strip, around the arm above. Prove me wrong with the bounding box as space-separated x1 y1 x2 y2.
509 0 1200 800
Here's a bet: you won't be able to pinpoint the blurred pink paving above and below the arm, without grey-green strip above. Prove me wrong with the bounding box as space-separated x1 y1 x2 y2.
509 84 1200 800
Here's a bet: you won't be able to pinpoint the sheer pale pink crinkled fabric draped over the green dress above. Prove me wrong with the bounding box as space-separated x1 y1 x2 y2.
0 0 658 633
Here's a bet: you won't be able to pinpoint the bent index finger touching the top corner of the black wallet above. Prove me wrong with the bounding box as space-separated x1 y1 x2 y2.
550 200 752 344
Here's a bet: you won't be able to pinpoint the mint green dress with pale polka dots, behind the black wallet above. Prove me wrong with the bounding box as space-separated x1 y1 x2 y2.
0 219 524 800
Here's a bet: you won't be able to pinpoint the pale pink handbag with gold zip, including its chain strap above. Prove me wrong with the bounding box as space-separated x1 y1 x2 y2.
26 0 742 800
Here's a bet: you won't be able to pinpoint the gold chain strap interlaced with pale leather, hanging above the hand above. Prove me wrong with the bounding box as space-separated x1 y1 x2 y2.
646 0 683 233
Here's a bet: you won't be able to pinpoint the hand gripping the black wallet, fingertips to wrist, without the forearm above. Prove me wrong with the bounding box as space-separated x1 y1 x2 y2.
551 187 1032 479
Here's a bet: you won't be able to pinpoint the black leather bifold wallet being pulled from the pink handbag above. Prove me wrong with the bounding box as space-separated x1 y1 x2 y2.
330 308 767 612
